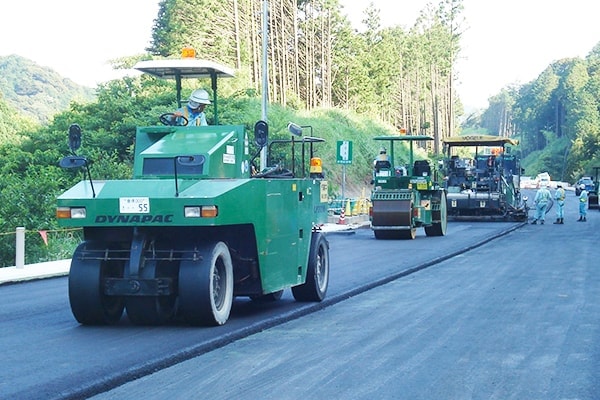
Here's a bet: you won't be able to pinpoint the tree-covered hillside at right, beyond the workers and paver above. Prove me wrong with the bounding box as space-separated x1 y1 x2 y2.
465 43 600 183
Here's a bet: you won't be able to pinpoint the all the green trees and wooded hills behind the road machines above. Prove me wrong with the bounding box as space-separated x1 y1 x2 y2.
0 0 600 266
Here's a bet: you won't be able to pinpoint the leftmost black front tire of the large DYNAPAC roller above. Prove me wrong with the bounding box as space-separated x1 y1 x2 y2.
69 242 124 325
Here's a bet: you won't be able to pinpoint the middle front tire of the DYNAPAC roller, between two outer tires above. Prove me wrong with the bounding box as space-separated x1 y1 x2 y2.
125 260 177 325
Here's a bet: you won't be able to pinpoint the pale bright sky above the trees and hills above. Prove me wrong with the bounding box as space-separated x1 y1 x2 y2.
0 0 600 109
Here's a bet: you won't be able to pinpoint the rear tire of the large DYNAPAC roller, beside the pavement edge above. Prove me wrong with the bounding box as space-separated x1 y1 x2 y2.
292 232 329 301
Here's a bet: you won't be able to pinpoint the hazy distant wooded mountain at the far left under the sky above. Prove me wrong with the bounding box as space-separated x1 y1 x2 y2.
0 55 95 124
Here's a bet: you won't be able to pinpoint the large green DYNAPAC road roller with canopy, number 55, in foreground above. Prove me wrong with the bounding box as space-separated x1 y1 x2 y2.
56 54 329 326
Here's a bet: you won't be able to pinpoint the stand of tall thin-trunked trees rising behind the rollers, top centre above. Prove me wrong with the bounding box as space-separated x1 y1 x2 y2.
147 0 463 153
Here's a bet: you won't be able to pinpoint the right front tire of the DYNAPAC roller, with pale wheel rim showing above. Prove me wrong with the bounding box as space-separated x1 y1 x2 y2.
179 242 233 326
